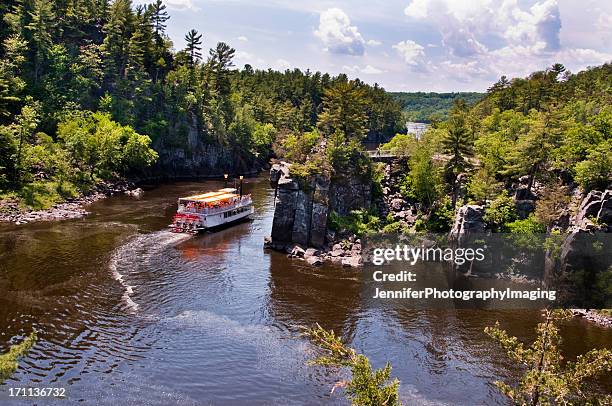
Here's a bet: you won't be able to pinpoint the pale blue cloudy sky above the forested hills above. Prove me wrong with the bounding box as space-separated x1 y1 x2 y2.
135 0 612 92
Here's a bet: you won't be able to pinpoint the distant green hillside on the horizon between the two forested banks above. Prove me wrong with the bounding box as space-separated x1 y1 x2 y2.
389 92 484 123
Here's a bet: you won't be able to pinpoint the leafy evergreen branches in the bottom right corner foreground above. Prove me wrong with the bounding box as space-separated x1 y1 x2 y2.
485 310 612 406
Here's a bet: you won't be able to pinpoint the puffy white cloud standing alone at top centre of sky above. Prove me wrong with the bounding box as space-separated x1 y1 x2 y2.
314 8 365 55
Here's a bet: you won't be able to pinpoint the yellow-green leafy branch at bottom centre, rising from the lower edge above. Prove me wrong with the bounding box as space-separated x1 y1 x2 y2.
304 324 402 406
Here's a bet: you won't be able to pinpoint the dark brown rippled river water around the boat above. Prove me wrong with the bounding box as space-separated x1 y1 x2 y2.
0 178 612 405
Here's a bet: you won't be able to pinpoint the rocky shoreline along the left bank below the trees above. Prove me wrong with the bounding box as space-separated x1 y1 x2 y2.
0 180 143 225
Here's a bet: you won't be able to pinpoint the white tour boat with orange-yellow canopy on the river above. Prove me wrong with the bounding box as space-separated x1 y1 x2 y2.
169 188 254 234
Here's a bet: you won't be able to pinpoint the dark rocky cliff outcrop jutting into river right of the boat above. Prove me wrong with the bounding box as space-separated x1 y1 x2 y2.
266 162 372 266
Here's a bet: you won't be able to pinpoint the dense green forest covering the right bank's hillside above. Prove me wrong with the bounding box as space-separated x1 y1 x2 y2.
385 64 612 232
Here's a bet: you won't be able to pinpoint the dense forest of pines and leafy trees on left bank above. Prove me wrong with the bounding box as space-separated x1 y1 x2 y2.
0 0 401 207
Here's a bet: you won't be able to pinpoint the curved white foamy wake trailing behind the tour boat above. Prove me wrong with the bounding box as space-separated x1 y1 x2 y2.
109 230 191 313
